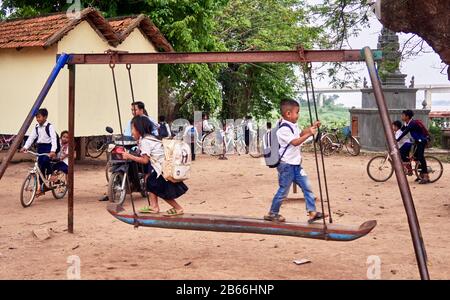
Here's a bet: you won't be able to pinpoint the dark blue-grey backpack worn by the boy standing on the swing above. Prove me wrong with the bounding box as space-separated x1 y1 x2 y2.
263 123 294 168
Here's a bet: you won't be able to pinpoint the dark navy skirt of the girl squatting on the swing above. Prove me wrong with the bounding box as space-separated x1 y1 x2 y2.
147 167 189 200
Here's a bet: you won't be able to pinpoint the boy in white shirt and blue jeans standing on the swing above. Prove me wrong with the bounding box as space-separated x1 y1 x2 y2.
264 99 325 224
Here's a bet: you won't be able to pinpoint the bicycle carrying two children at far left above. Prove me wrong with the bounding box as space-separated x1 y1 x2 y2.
20 151 67 208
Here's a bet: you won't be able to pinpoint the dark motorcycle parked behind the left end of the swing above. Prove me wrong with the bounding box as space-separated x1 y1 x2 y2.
106 127 148 205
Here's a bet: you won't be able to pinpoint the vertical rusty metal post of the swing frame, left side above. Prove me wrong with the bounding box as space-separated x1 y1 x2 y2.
67 65 75 233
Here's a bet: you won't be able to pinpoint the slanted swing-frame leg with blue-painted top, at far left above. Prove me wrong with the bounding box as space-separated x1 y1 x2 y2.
0 54 71 179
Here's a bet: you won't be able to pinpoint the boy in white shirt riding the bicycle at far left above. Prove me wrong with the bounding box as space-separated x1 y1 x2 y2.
20 108 58 176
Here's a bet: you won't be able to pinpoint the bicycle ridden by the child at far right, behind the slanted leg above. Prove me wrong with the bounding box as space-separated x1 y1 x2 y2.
367 146 444 183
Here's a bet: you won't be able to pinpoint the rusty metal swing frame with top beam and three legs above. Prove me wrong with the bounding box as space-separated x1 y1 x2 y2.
0 47 429 279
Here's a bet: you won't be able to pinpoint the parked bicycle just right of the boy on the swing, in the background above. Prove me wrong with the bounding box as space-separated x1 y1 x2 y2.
320 126 361 156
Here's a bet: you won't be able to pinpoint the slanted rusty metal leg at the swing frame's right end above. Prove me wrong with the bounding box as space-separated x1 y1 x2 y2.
363 47 430 280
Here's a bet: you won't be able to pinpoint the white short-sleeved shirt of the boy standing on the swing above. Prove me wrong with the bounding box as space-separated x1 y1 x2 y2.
277 120 302 166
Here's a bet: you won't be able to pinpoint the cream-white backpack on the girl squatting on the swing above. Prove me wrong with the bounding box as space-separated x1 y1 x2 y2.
162 139 192 183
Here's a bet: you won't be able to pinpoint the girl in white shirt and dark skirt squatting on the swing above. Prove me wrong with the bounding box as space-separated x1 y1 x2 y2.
123 116 188 217
